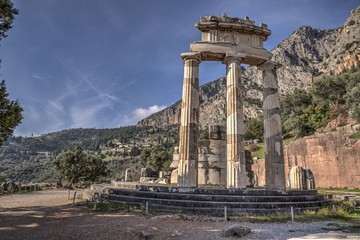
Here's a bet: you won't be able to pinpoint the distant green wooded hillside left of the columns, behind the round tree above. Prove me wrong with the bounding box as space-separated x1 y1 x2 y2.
0 126 178 182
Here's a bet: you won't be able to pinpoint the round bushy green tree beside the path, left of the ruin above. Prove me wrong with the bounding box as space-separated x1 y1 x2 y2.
53 147 108 187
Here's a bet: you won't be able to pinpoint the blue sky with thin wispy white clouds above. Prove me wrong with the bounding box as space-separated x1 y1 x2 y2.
0 0 359 135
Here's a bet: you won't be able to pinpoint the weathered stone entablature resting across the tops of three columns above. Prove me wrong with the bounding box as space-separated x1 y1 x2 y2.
190 13 271 65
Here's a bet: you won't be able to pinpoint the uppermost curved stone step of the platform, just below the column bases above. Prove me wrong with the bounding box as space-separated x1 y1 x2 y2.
108 189 324 202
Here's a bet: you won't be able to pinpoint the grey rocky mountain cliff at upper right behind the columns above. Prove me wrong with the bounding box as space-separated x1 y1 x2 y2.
246 7 360 93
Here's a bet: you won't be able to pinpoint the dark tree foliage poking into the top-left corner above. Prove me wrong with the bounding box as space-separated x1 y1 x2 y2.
0 0 19 40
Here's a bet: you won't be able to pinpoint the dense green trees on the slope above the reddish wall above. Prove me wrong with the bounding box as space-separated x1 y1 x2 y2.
280 68 360 137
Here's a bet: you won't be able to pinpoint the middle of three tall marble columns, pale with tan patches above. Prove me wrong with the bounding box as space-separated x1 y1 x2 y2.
223 54 247 188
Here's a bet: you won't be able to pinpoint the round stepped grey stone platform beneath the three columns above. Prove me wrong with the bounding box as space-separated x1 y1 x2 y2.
87 183 327 216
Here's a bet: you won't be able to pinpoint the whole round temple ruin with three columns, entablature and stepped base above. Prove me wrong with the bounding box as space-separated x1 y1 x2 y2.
84 15 326 218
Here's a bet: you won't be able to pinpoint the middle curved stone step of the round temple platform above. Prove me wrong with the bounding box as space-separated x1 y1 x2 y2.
104 194 326 209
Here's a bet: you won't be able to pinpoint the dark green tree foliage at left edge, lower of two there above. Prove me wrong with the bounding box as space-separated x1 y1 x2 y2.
0 81 23 146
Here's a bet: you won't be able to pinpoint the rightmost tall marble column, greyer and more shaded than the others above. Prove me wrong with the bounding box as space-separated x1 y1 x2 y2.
259 62 286 189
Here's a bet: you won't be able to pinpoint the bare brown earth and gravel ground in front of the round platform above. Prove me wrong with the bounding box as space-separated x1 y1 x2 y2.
0 190 360 240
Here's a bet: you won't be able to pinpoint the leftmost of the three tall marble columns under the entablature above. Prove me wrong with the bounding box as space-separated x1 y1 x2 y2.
178 53 201 187
